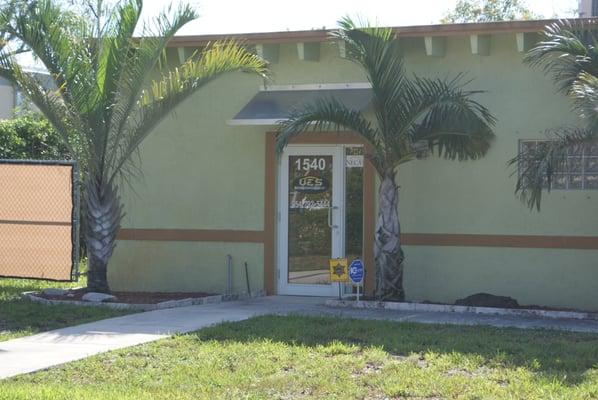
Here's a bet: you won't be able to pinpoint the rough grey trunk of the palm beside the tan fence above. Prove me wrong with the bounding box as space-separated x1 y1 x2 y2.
85 176 124 293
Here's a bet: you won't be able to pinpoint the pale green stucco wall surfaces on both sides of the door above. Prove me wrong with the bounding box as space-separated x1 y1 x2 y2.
109 34 598 310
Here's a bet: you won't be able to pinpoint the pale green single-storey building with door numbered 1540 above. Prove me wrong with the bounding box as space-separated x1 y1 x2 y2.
109 21 598 310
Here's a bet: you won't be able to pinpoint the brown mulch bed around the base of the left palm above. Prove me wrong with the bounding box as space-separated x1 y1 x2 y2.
37 288 212 304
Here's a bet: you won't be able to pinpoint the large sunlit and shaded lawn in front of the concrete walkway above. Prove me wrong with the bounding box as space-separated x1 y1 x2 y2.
0 316 598 400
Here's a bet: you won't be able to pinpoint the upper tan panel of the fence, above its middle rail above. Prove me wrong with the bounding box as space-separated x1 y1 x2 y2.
0 164 72 222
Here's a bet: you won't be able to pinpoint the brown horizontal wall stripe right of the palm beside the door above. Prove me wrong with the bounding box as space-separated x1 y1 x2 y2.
401 233 598 250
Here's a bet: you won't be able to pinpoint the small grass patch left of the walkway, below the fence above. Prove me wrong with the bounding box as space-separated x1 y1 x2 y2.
0 278 128 341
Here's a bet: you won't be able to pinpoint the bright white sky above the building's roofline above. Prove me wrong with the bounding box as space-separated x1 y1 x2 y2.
143 0 578 35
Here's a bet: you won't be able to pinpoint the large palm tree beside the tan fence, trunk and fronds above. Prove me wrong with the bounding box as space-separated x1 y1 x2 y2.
0 0 266 291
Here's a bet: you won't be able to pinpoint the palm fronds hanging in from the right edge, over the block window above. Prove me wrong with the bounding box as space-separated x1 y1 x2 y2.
509 21 598 210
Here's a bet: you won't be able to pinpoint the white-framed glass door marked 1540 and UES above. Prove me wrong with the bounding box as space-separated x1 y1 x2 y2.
278 145 345 296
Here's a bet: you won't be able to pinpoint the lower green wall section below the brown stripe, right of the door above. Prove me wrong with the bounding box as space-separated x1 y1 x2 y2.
404 246 598 310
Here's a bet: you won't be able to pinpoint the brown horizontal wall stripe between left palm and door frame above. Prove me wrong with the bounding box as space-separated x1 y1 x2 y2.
117 229 265 243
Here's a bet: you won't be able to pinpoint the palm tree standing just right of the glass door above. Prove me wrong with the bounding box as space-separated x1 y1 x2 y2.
278 18 494 301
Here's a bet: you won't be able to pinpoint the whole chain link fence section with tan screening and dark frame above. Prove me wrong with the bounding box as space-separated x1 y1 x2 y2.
0 160 79 281
